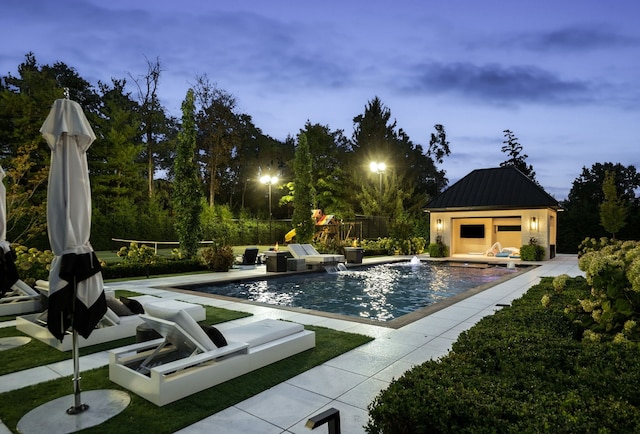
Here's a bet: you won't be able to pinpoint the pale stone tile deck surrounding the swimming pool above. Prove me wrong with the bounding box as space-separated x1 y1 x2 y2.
0 255 584 434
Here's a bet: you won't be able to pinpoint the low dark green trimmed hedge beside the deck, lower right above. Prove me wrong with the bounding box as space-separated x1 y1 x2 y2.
366 278 640 434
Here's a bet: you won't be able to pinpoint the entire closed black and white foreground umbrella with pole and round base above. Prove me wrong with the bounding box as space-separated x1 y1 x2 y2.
18 91 130 433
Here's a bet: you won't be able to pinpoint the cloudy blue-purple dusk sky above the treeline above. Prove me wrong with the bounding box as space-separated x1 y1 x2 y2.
0 0 640 200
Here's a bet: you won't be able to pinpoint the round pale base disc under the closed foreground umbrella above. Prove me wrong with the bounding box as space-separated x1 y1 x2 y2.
17 390 131 434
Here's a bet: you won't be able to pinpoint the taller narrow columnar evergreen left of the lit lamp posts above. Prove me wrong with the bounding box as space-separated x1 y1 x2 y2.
173 89 201 258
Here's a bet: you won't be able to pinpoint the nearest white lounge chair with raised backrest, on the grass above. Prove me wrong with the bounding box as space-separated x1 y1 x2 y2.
109 307 315 406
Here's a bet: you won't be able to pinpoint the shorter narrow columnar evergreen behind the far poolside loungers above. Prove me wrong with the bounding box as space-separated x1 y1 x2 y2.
291 133 315 243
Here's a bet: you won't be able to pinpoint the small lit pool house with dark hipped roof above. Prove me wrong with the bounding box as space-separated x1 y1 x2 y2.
425 167 561 260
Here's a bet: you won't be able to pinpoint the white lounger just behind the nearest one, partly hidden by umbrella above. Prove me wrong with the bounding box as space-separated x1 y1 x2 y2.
16 295 206 351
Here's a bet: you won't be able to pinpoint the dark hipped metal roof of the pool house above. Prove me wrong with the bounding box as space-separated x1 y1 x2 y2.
425 166 560 211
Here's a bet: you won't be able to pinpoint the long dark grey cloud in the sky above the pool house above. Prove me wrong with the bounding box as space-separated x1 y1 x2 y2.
402 62 593 105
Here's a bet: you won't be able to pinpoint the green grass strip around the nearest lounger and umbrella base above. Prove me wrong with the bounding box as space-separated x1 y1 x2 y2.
0 326 371 434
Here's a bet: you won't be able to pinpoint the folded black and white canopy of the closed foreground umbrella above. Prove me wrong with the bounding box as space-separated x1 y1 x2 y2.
40 99 107 341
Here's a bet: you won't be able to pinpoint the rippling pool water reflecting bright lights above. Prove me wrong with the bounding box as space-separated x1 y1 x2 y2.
185 262 517 321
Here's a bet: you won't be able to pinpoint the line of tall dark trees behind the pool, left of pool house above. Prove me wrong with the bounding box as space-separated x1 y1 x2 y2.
0 53 449 248
